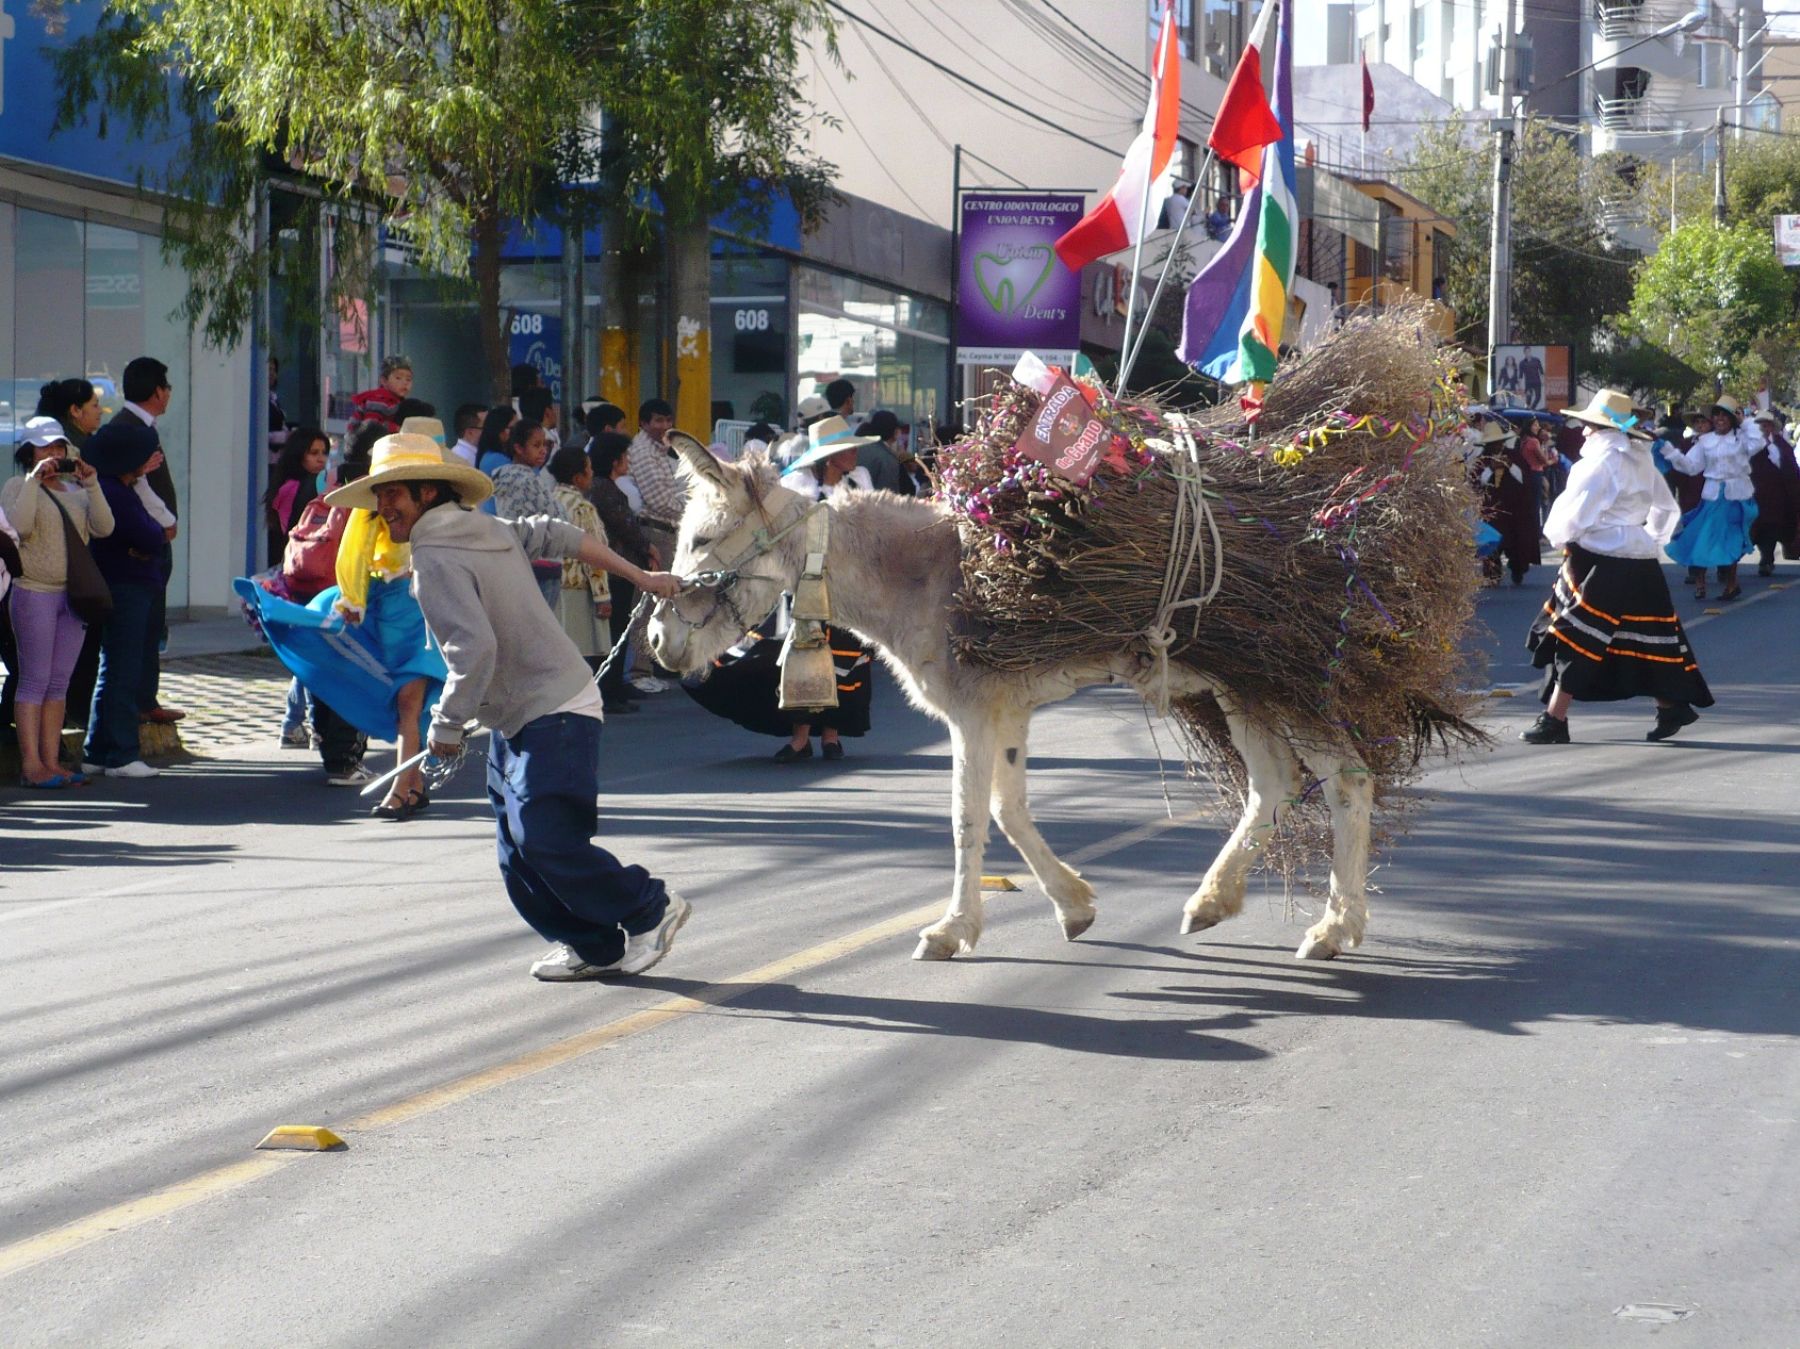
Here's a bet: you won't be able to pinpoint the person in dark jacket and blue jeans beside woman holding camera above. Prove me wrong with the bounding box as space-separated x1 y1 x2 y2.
81 427 169 778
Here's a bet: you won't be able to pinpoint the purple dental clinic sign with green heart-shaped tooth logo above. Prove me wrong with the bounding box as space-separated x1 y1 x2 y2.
956 193 1087 367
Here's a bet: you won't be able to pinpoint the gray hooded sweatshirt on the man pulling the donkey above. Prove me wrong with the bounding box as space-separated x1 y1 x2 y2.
410 506 592 744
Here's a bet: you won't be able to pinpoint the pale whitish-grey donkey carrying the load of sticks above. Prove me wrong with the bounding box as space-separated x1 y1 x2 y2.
650 432 1373 960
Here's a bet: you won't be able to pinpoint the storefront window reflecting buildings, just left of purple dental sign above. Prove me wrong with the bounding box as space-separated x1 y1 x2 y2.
794 267 950 439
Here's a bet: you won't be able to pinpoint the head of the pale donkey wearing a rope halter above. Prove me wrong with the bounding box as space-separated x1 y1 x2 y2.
650 430 812 674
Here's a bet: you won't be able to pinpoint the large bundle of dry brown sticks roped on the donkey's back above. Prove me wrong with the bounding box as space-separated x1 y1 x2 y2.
938 308 1480 799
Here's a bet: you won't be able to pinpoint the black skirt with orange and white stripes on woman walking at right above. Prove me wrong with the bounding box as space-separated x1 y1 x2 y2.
1526 546 1712 708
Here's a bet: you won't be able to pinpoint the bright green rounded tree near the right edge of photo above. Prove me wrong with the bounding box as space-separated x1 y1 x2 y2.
1625 220 1795 387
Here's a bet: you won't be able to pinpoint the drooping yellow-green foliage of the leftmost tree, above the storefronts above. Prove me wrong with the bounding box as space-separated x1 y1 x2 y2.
58 0 594 393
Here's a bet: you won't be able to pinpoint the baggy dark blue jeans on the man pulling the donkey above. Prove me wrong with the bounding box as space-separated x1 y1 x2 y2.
488 711 668 965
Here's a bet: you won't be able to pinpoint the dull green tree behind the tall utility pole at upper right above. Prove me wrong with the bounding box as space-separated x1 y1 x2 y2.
1395 113 1640 369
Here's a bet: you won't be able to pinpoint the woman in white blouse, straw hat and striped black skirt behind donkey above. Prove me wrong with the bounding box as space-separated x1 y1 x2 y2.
1519 389 1712 744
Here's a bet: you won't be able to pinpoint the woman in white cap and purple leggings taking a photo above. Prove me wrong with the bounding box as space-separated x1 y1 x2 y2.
0 416 113 791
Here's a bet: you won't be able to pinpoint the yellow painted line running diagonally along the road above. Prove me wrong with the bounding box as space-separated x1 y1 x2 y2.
0 810 1199 1279
